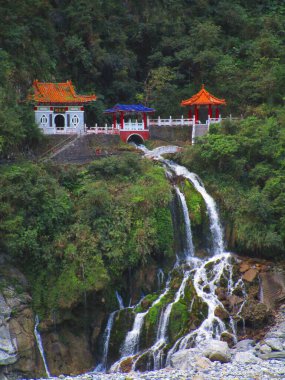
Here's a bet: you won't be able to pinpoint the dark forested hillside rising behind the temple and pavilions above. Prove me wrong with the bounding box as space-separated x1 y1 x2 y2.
0 0 285 155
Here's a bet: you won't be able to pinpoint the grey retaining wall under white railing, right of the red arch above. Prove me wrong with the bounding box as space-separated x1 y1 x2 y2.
149 126 192 143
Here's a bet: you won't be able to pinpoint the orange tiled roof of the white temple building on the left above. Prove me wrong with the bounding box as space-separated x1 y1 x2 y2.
30 80 96 104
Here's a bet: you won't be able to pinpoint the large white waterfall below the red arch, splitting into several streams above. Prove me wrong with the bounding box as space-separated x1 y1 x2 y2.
105 146 243 371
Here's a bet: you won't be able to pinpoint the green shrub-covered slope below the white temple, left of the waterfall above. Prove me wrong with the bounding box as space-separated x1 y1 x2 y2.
0 153 173 312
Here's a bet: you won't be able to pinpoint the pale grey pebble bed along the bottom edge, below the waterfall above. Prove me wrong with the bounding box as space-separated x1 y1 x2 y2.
34 307 285 380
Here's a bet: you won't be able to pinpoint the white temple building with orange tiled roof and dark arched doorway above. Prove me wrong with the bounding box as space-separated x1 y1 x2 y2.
29 80 96 134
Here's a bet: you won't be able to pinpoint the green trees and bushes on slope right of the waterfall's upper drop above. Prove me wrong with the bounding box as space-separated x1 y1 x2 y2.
179 107 285 256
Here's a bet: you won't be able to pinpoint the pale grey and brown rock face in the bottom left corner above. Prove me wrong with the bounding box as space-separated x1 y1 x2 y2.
0 259 44 378
